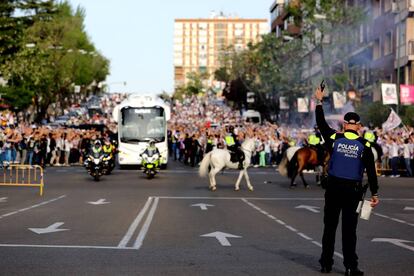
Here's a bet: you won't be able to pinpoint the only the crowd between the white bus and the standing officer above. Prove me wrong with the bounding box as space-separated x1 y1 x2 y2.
169 96 296 167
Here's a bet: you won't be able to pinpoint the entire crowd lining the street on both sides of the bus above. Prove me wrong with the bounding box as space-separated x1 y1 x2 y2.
0 94 414 177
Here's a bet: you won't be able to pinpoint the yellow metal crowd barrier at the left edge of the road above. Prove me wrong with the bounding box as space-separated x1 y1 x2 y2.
0 165 44 195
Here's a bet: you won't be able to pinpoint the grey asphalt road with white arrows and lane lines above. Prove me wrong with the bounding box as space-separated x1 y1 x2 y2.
0 161 414 275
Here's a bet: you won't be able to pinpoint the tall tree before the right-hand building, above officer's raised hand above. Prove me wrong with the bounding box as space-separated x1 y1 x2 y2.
288 0 366 91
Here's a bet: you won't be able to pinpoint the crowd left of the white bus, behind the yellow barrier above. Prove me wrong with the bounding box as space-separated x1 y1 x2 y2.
0 94 126 167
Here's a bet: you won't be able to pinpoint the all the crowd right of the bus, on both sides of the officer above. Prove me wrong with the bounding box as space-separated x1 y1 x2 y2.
169 96 414 177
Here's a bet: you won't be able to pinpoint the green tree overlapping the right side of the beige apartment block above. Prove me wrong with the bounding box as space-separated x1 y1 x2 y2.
215 34 305 108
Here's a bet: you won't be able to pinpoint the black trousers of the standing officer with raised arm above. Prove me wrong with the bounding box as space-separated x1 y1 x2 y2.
319 177 362 269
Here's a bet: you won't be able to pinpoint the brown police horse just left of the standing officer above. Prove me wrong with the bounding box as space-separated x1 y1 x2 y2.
278 147 330 188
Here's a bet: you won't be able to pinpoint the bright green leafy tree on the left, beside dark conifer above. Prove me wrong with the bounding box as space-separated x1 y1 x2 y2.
0 1 109 120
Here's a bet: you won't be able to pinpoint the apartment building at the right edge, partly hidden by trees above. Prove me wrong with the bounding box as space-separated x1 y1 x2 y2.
270 0 414 101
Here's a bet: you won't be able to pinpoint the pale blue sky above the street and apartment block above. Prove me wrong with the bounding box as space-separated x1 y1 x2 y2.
69 0 274 94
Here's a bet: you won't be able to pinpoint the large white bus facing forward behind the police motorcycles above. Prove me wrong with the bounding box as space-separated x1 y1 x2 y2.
112 94 171 168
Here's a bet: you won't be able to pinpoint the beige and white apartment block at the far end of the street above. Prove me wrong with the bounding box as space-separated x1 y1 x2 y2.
174 14 269 87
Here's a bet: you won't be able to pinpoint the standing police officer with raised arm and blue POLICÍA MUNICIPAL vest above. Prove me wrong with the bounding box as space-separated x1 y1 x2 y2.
315 89 378 275
